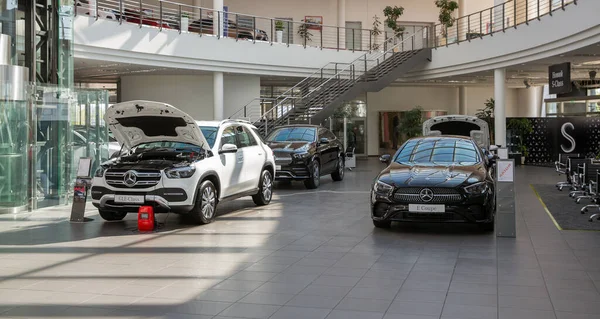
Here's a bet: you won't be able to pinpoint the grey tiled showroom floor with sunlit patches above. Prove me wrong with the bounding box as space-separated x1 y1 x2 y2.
0 160 600 319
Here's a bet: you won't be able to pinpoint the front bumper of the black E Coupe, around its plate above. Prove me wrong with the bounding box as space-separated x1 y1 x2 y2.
371 194 495 224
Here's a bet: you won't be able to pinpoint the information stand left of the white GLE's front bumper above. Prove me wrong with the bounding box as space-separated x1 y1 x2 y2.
71 157 92 223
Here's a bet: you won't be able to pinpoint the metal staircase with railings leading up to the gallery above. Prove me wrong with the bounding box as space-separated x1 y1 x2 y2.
230 27 431 135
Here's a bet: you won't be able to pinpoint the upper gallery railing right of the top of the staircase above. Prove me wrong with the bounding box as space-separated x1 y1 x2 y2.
433 0 577 48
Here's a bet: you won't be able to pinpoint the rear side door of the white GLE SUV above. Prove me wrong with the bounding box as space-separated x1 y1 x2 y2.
236 125 265 192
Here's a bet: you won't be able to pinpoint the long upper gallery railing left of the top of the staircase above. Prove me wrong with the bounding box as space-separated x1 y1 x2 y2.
74 0 385 51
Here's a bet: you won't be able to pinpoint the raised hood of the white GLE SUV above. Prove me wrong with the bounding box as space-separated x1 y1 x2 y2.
104 100 209 150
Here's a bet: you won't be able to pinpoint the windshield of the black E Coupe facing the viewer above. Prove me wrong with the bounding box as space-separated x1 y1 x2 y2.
394 138 480 166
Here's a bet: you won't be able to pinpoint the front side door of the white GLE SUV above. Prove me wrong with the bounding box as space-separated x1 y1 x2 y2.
218 125 244 198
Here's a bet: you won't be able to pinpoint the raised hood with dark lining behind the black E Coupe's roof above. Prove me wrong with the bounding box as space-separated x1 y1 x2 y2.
423 115 490 149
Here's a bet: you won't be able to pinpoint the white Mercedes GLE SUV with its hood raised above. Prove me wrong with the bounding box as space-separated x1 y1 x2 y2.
91 101 275 224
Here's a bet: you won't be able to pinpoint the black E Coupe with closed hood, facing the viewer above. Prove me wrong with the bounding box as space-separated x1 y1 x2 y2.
371 136 495 231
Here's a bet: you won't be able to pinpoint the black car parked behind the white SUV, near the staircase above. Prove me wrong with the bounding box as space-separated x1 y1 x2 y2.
266 125 345 189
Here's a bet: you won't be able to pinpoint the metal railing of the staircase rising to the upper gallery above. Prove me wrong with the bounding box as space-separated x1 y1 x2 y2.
256 27 431 135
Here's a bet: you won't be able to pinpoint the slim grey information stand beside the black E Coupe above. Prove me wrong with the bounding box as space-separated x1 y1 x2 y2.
495 159 517 238
